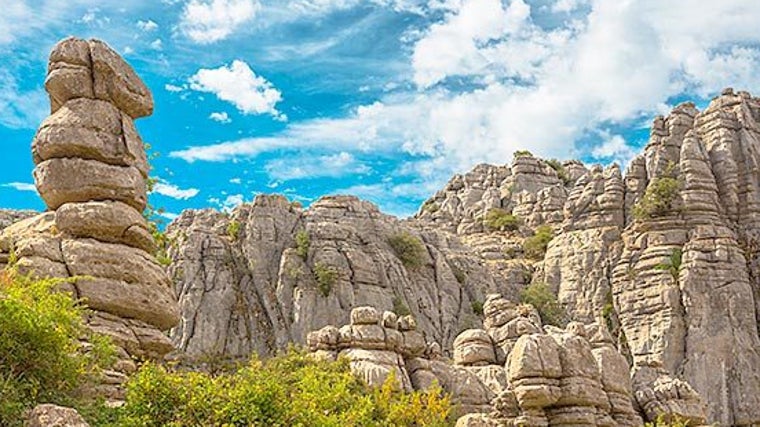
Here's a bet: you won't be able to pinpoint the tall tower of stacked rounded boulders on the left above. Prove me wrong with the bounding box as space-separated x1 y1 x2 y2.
0 38 179 398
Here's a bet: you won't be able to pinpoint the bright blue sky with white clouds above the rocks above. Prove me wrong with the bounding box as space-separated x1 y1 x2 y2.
0 0 760 221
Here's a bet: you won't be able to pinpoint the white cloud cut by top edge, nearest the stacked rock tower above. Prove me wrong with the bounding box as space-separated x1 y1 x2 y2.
179 0 261 44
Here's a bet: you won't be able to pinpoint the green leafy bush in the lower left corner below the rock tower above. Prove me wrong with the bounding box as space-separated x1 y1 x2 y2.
0 269 113 426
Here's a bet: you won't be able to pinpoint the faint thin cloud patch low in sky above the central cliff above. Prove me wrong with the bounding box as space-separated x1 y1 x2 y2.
264 151 371 181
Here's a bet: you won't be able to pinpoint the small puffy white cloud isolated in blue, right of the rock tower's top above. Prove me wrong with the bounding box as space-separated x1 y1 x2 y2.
190 60 287 120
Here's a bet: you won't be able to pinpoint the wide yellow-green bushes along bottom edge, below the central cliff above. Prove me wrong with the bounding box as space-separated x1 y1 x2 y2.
117 350 453 427
